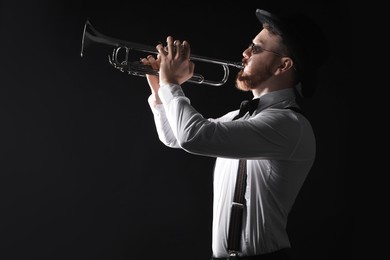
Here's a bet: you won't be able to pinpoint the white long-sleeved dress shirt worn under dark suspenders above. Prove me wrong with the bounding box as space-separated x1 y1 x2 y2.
149 84 316 257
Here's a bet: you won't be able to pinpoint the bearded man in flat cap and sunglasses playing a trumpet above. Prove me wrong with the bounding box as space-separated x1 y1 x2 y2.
142 9 326 260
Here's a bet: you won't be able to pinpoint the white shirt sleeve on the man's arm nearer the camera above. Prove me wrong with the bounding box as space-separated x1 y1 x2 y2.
158 84 311 159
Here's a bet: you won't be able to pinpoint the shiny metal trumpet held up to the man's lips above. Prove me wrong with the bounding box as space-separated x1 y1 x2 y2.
80 20 244 86
